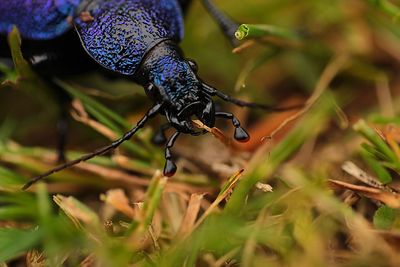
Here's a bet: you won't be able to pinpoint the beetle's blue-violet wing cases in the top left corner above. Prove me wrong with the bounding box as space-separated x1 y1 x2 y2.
0 0 81 40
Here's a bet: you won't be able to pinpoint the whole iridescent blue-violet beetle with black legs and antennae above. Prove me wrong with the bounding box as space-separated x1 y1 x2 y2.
0 0 294 188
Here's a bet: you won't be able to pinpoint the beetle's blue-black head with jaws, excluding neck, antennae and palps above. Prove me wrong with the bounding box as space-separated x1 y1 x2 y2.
146 55 215 135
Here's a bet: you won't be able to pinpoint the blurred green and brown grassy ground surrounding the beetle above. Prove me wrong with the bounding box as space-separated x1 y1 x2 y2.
0 0 400 266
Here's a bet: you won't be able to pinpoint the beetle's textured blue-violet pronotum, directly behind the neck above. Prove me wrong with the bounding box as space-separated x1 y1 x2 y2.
74 0 183 75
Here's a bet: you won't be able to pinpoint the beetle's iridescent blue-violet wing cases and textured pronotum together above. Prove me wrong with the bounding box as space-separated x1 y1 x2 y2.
0 0 183 75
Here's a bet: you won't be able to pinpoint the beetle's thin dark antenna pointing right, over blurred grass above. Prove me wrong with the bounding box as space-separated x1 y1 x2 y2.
203 83 304 112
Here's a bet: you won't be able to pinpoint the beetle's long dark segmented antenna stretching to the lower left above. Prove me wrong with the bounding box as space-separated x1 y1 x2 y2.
22 104 162 190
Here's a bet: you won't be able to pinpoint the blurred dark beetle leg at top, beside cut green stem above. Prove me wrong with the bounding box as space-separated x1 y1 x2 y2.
202 0 239 47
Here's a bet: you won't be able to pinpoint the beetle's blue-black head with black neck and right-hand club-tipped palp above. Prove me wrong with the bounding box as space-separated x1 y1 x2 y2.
138 40 248 139
